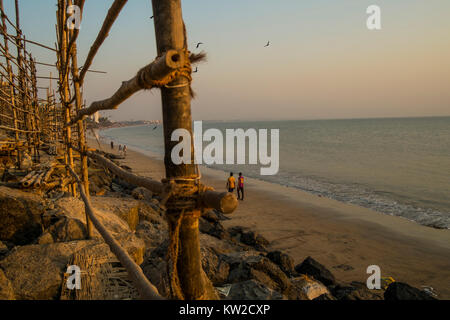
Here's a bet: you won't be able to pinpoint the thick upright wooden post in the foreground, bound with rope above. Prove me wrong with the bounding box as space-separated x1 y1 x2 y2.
152 0 218 300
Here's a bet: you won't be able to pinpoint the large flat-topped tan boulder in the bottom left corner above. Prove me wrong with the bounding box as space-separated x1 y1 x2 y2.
0 241 93 300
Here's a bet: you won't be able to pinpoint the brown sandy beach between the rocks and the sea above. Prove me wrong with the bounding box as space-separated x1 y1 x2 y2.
89 140 450 299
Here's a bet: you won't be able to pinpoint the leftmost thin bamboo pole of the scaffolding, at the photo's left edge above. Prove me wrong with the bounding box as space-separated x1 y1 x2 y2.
0 0 22 168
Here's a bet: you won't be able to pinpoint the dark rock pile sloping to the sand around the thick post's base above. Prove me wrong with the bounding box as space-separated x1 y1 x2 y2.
143 211 433 300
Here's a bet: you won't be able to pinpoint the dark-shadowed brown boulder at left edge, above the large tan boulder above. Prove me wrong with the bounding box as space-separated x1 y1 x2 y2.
0 187 45 245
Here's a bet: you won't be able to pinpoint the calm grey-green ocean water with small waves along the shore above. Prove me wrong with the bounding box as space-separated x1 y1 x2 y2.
101 117 450 229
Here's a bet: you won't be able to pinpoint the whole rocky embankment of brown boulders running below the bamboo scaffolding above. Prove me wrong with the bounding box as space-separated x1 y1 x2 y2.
0 152 433 300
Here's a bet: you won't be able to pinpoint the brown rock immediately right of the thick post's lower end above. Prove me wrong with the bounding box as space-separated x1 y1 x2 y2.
201 247 230 286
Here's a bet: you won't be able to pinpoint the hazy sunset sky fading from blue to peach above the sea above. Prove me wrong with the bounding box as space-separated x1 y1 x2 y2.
4 0 450 120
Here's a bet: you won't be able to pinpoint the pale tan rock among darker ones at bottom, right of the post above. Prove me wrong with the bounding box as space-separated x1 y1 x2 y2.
288 275 330 300
